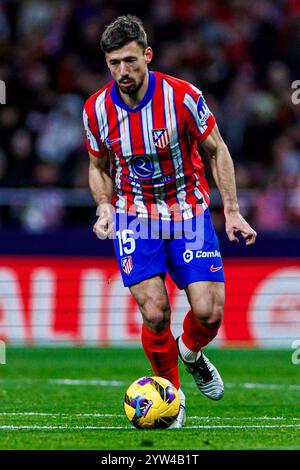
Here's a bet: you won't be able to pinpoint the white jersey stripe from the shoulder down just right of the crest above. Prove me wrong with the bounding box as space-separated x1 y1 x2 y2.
163 80 193 219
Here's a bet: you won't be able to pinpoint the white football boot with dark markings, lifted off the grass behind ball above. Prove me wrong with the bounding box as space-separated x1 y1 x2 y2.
176 338 224 400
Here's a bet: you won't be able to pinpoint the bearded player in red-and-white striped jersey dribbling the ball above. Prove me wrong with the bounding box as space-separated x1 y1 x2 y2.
83 15 256 427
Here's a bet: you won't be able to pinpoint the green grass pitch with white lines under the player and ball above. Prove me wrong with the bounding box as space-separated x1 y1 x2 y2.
0 347 300 451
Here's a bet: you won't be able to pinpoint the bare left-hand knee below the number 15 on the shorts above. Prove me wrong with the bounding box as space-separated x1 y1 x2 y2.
129 275 171 323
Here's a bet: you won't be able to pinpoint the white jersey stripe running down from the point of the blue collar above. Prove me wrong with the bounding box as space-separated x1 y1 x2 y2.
141 100 171 220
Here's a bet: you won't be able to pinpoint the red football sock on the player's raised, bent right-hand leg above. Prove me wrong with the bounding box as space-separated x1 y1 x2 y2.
181 310 219 352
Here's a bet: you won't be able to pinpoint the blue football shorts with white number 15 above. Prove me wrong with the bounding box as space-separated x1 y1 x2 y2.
114 209 225 289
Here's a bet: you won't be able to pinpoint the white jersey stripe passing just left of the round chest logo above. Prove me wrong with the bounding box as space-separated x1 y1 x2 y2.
115 105 148 217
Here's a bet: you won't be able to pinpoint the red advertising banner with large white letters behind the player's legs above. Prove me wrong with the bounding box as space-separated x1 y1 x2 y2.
0 257 300 347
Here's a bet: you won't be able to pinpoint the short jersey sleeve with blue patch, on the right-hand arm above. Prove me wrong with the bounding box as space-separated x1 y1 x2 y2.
184 84 216 142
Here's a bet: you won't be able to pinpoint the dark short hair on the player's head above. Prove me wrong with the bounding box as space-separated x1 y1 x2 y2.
101 15 148 53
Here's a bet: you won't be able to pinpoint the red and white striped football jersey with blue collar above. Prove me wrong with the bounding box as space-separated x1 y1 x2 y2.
83 72 215 220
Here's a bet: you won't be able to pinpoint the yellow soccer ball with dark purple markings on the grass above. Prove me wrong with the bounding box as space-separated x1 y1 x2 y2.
124 377 180 429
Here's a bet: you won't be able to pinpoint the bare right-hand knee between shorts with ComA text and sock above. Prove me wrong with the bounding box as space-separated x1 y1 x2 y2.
185 281 225 324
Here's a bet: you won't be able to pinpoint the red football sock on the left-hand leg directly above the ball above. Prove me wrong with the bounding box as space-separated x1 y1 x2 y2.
142 324 180 388
